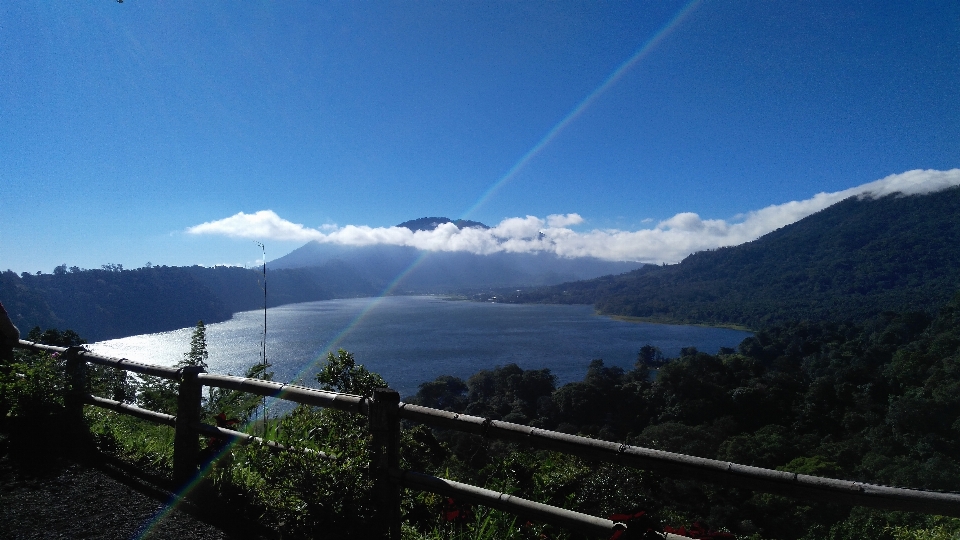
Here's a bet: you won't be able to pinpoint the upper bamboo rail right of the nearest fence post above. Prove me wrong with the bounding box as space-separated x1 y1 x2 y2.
400 403 960 517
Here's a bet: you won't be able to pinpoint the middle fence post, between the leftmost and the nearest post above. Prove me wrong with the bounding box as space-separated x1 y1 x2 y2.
173 366 204 486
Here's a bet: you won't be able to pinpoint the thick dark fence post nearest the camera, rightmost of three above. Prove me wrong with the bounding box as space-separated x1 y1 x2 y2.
370 388 400 540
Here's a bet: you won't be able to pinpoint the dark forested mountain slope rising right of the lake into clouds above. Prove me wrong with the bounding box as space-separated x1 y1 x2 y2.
498 188 960 328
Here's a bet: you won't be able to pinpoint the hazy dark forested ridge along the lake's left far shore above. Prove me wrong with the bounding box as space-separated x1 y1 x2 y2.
0 263 375 341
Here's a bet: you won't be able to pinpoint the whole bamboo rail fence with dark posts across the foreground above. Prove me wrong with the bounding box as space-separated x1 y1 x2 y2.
13 340 960 539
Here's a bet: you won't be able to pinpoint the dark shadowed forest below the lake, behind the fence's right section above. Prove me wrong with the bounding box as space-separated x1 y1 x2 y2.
404 295 960 538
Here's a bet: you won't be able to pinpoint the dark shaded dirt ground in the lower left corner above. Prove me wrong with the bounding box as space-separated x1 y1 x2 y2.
0 433 280 540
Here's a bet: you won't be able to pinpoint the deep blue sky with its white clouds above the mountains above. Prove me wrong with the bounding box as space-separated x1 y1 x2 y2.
0 0 960 272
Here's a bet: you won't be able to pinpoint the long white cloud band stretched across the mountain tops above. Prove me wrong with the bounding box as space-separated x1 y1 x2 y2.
187 169 960 263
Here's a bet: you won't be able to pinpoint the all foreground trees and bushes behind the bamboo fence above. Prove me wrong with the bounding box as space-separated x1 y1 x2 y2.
0 295 960 540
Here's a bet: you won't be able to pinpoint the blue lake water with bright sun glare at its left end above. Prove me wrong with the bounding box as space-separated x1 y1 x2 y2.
89 296 750 396
